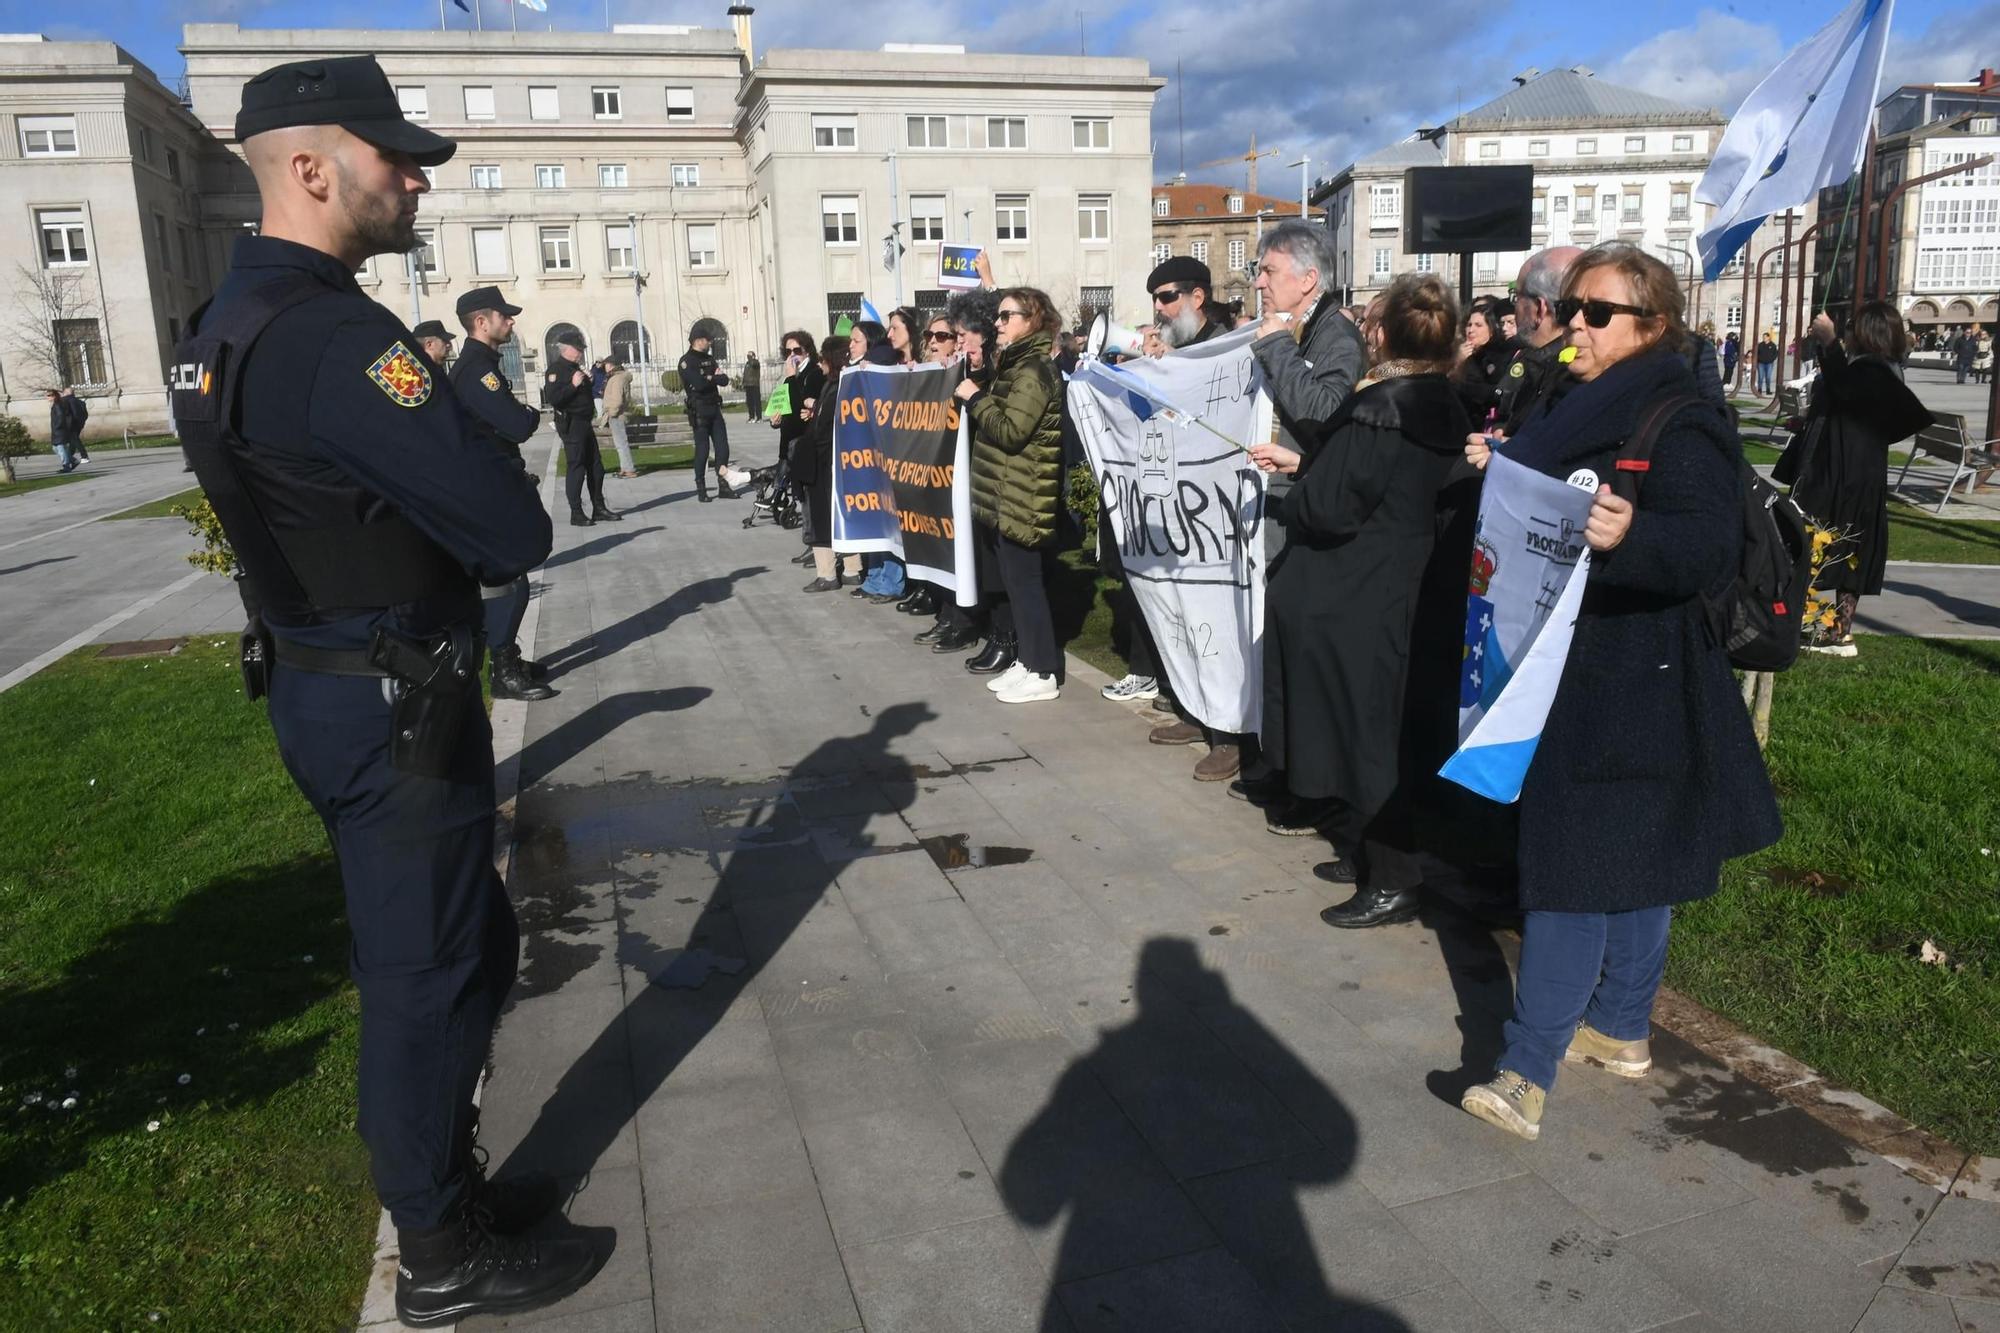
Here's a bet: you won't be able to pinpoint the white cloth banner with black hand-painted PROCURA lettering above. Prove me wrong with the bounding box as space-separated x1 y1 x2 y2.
1068 328 1270 733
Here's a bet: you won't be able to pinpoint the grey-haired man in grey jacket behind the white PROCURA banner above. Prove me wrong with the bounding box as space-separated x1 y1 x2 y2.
1250 222 1368 460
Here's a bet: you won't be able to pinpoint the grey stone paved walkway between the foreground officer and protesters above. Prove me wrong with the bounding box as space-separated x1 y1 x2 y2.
450 446 2000 1333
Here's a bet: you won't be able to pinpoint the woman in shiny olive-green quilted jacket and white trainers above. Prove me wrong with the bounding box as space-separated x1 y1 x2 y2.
956 286 1062 703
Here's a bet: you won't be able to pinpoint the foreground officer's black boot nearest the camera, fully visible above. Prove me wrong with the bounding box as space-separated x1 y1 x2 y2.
396 1203 604 1329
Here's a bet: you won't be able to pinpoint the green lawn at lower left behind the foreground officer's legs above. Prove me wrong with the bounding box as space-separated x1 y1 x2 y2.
0 638 376 1331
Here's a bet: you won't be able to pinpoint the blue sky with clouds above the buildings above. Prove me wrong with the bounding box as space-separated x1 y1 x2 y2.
19 0 2000 192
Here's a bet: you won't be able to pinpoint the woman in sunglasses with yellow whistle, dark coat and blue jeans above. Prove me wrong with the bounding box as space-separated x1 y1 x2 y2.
1460 244 1782 1139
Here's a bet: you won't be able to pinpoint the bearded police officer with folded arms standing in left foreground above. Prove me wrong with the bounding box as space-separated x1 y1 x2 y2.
170 56 602 1325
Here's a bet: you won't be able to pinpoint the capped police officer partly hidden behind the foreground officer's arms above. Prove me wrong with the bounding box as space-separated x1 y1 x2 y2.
448 286 560 701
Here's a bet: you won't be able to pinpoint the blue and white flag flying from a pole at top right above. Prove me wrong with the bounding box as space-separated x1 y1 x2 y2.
1694 0 1896 282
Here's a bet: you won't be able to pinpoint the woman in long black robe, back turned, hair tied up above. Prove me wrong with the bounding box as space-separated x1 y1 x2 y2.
1250 274 1468 929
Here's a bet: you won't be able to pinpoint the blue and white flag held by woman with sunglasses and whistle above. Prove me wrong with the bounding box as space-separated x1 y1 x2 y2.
1438 454 1598 803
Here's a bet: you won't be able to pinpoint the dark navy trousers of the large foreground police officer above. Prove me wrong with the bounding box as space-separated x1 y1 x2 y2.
270 664 520 1229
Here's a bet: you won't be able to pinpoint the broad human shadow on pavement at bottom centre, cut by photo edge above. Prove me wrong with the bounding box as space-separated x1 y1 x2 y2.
998 937 1408 1333
